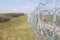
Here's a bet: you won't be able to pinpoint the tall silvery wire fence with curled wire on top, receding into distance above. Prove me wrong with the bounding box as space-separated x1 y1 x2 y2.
27 0 60 40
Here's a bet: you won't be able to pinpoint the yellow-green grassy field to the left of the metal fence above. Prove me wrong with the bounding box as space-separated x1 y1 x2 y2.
0 15 37 40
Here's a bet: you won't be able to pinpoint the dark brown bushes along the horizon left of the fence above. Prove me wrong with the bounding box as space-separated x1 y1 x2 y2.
0 13 24 22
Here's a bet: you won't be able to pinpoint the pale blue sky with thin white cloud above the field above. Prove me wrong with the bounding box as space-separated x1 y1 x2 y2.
0 0 60 13
